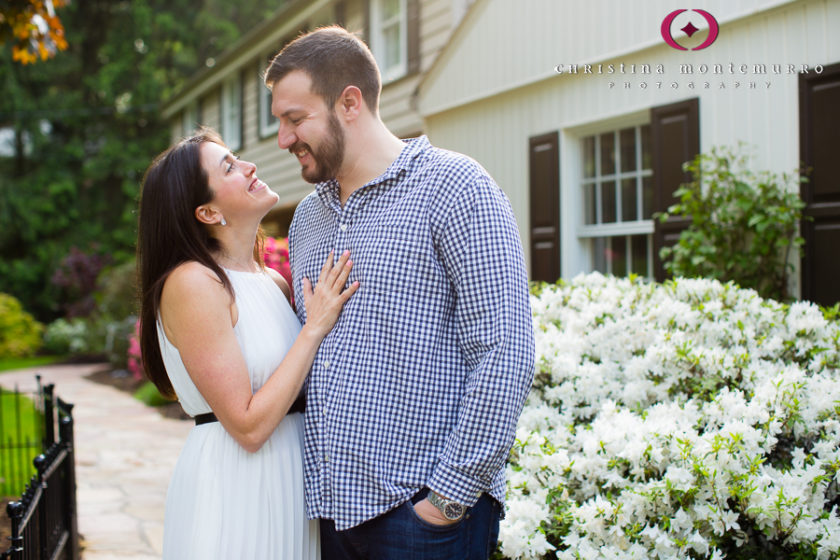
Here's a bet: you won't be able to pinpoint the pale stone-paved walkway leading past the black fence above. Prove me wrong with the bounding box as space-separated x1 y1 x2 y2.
0 364 192 560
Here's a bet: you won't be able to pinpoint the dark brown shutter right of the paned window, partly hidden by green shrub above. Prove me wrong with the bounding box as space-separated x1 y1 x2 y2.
650 97 700 282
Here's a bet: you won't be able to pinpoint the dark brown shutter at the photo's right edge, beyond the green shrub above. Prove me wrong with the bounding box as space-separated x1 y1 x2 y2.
799 64 840 305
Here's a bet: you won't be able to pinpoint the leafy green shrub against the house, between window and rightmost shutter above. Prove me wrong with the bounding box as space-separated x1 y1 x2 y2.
660 147 805 301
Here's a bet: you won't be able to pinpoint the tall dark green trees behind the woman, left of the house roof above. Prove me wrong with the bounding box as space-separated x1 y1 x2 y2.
0 0 279 322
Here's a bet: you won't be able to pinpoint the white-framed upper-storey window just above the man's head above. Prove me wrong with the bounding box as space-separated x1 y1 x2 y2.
370 0 408 83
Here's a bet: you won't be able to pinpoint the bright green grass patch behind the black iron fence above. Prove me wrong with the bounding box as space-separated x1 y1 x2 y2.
0 389 43 497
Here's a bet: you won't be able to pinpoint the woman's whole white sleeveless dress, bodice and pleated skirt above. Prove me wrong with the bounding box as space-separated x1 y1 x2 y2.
158 269 320 560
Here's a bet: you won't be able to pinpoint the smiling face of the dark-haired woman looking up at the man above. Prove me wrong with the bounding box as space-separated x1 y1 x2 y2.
199 142 279 224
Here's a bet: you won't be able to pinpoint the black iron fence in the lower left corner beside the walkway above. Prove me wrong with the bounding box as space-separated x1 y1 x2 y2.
0 380 79 560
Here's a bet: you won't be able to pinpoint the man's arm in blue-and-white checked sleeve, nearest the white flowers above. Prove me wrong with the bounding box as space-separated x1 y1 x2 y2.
428 167 534 506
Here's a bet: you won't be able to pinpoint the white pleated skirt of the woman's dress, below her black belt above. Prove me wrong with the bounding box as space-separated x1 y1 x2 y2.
163 414 320 560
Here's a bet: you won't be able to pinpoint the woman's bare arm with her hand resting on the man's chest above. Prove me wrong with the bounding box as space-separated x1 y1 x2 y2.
161 253 358 452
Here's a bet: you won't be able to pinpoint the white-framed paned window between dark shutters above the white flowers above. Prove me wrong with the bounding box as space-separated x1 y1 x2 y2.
578 125 653 278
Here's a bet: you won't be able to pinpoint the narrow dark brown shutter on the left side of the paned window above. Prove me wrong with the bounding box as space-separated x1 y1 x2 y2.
528 132 560 282
